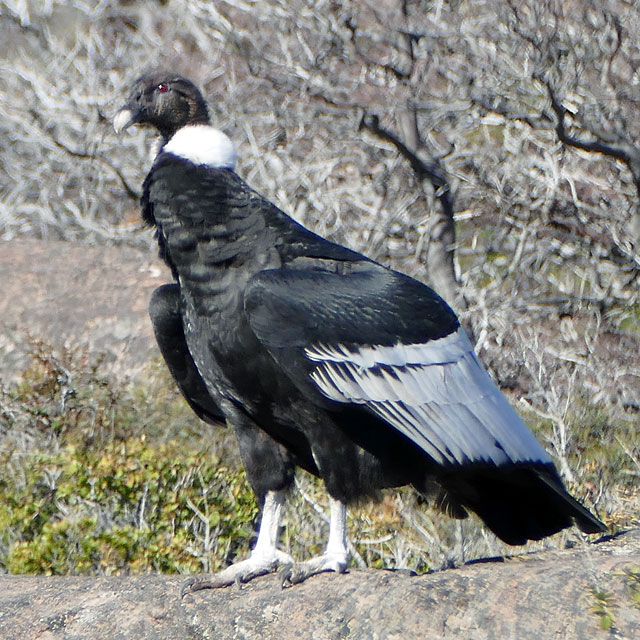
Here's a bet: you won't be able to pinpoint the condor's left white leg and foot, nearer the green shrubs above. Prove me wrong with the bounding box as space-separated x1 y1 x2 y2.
182 491 293 596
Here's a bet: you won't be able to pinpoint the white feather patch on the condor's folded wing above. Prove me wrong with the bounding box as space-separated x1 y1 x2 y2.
305 328 551 465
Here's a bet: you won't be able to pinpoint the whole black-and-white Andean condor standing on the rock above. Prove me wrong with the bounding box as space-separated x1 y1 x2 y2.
114 72 605 588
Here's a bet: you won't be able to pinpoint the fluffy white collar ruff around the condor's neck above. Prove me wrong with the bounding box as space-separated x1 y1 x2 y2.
162 124 238 169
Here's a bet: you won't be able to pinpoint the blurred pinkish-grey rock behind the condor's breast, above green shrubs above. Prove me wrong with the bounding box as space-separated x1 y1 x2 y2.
0 238 170 381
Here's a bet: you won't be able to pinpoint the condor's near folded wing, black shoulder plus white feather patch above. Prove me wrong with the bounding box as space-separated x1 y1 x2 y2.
245 263 551 465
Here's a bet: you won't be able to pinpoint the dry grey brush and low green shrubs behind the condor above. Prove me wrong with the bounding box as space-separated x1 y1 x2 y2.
0 0 640 573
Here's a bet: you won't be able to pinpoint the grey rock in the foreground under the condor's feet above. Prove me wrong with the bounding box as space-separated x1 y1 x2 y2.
0 530 640 640
